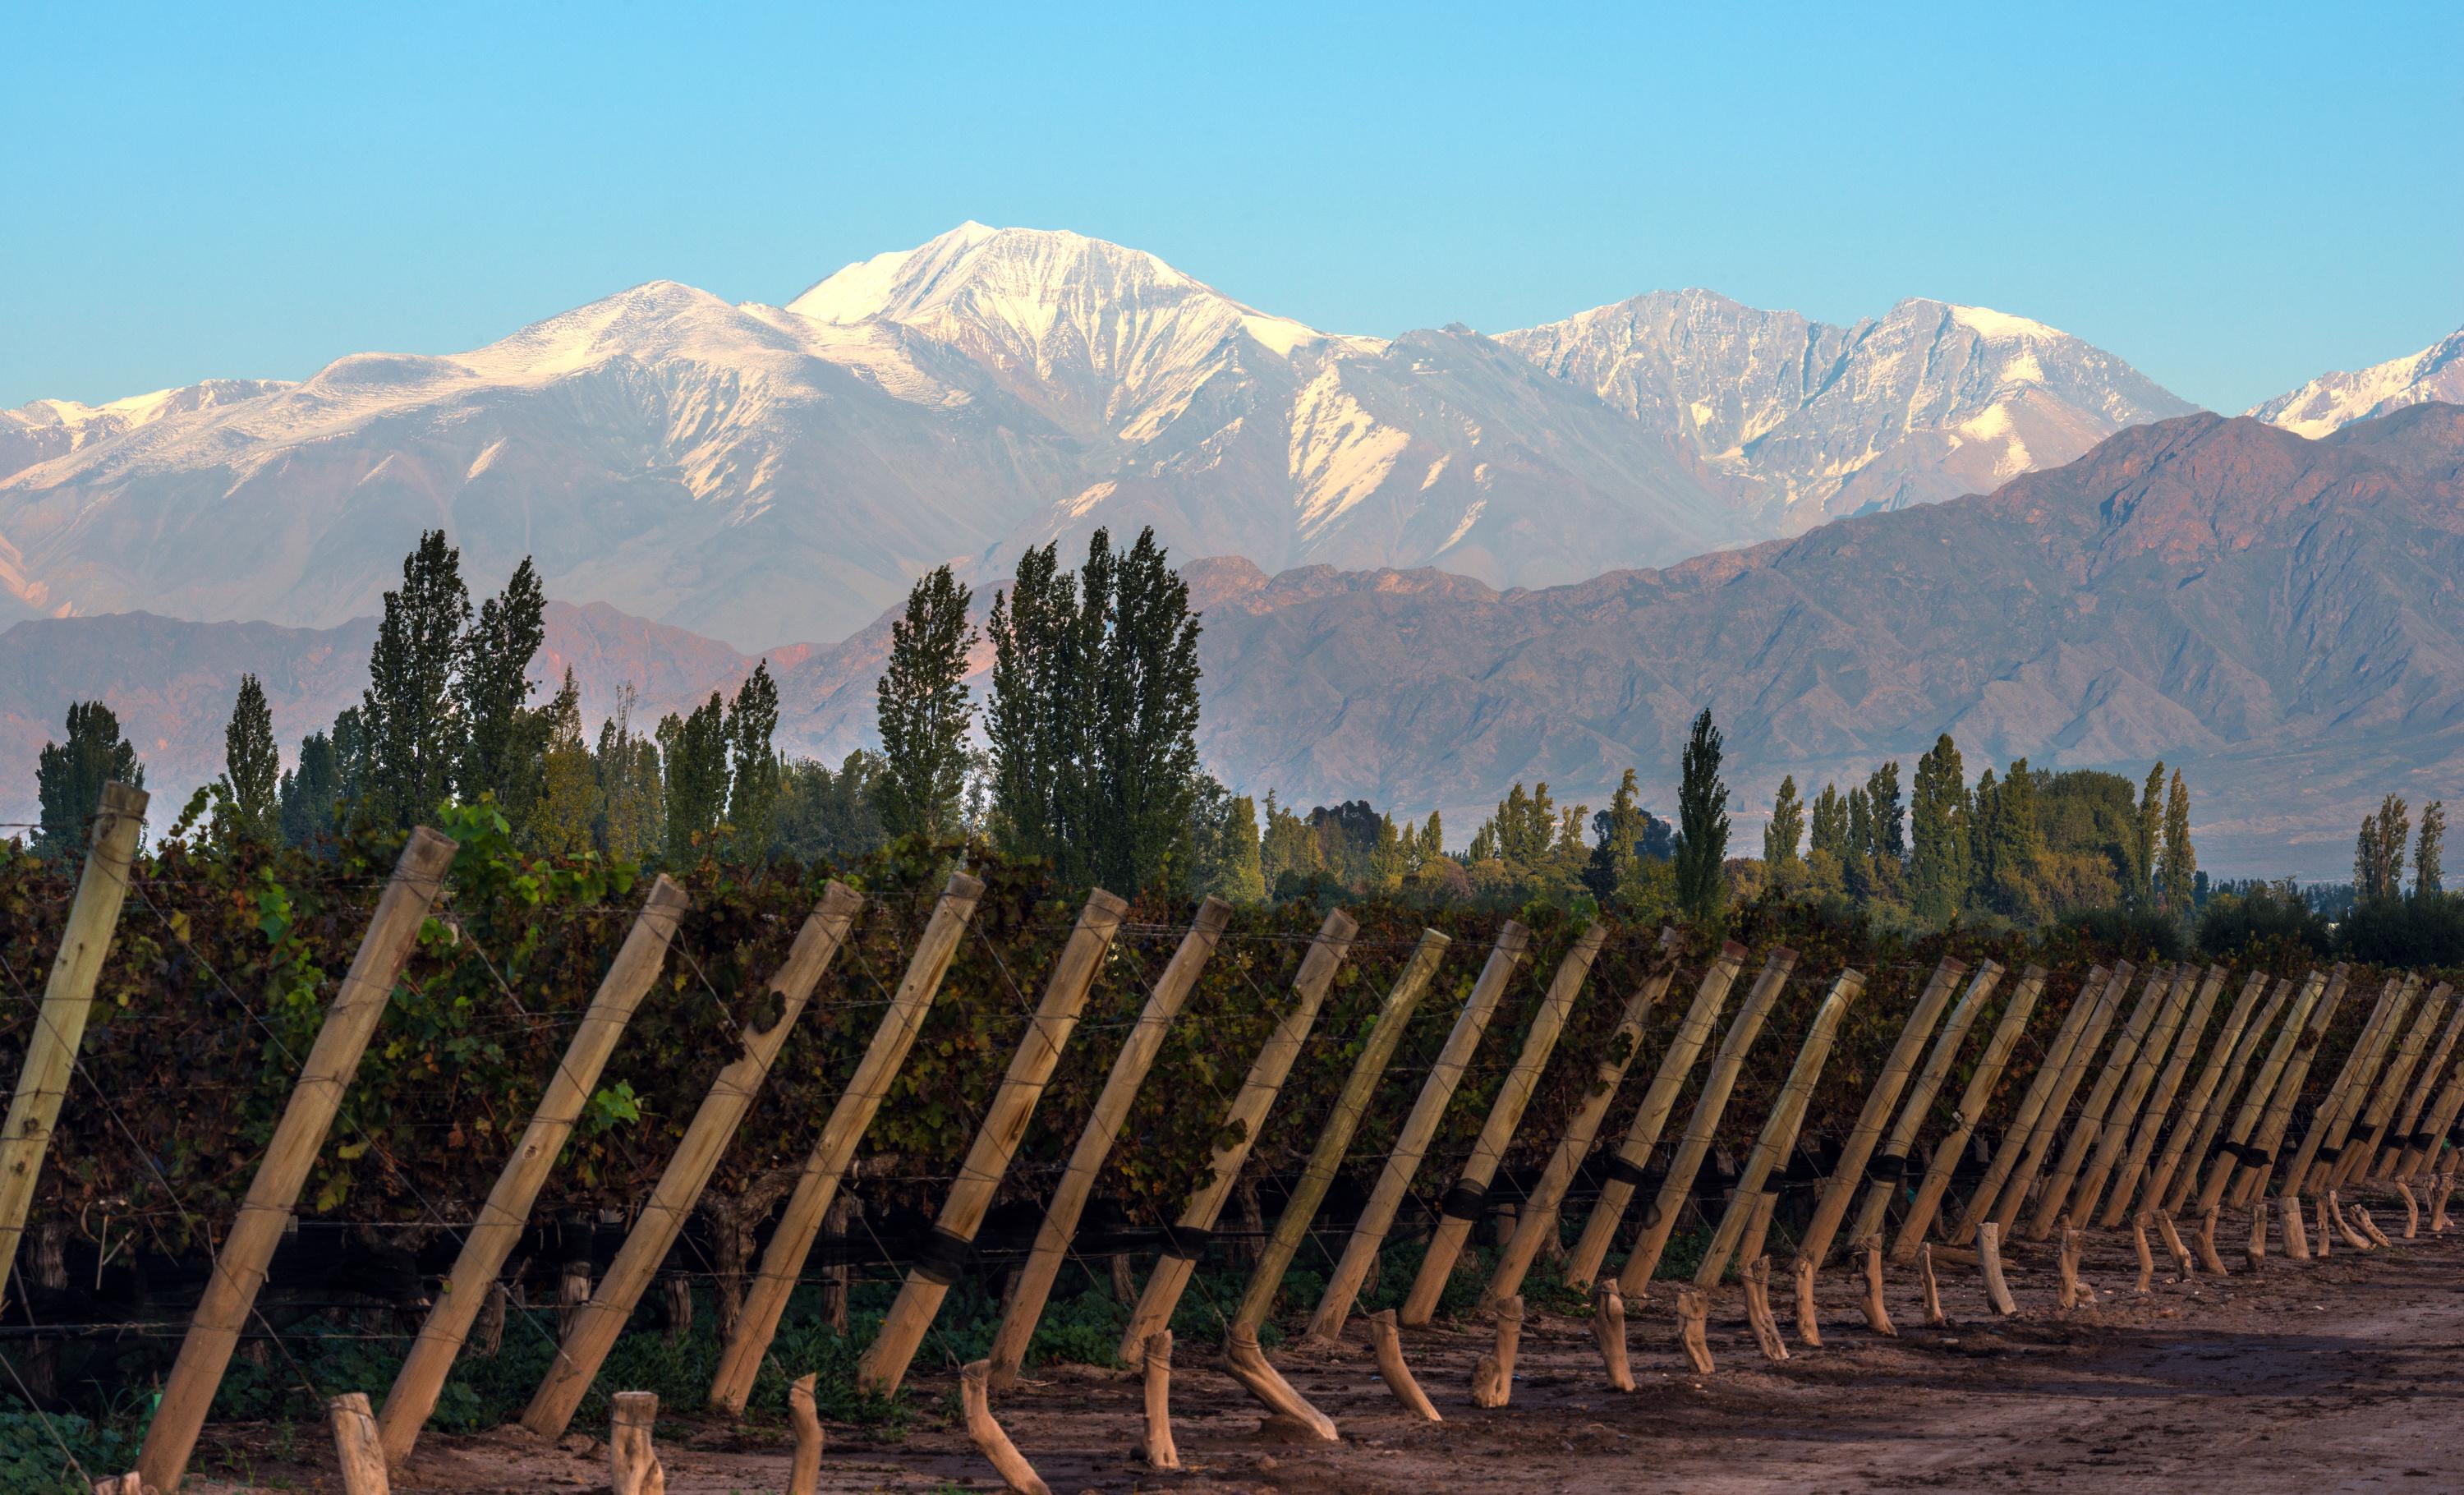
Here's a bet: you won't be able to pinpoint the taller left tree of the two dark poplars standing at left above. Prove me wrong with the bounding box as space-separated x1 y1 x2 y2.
357 530 471 827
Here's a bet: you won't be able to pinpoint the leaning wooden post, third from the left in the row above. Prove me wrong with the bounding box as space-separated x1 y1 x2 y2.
377 872 692 1465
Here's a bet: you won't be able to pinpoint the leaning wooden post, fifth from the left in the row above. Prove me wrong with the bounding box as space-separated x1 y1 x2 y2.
710 872 983 1416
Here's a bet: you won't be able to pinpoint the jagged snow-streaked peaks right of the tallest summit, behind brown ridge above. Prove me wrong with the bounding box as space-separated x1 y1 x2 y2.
1501 291 2195 532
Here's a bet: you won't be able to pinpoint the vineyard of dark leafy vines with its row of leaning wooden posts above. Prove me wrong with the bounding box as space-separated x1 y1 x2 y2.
0 790 2464 1495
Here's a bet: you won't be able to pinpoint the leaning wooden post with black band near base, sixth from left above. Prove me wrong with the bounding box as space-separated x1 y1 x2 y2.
855 889 1129 1396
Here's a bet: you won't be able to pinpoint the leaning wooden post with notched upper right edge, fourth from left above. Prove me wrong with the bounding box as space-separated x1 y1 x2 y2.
522 879 865 1441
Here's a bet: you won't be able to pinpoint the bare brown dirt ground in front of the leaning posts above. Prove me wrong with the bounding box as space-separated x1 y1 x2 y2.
192 1199 2464 1495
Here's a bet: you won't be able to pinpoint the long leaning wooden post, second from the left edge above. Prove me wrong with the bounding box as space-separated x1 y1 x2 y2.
138 825 456 1495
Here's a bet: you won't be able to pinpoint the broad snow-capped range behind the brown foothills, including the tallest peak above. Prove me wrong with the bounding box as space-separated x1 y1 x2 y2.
0 224 2186 648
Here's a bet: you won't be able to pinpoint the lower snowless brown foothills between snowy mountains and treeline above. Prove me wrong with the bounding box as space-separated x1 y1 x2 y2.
0 404 2464 876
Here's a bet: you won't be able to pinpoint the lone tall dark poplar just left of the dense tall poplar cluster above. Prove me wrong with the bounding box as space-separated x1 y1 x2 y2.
872 567 976 835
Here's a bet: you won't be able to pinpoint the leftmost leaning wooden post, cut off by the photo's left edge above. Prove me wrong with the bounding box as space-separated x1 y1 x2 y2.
0 783 145 1293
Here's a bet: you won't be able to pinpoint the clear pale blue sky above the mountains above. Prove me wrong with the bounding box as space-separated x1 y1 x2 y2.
0 2 2464 409
